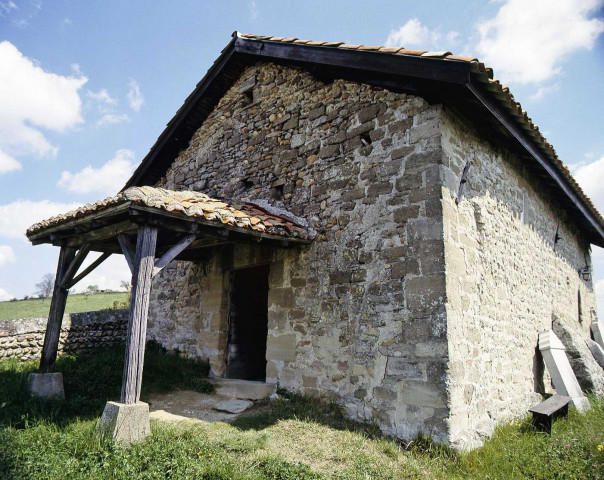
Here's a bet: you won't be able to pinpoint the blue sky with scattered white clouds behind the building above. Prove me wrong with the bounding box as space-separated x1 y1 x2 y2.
0 0 604 310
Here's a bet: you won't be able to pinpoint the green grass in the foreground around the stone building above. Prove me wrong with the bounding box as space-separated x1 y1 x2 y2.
0 347 604 480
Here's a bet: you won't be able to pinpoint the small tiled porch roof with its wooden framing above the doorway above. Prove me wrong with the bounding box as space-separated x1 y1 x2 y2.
26 186 315 257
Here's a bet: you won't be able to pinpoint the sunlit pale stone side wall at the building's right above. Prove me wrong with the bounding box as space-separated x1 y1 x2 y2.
441 106 595 448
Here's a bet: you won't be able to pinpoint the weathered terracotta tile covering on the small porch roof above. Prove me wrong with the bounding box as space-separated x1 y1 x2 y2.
26 187 314 240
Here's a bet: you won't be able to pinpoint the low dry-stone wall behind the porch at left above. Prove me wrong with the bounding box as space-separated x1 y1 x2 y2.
0 309 128 360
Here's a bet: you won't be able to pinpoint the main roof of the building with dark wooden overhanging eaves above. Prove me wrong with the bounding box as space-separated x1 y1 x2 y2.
124 32 604 247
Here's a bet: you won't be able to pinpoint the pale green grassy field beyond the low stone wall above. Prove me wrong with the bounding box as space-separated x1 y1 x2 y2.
0 292 128 320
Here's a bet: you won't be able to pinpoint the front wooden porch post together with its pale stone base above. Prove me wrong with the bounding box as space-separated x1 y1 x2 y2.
99 225 157 444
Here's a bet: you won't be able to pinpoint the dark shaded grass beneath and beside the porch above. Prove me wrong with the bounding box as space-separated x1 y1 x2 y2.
0 344 212 429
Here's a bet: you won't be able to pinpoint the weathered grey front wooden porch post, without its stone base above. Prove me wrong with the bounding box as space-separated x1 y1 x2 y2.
121 225 157 404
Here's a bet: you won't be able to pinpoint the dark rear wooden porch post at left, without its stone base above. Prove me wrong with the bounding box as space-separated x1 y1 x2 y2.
39 247 76 373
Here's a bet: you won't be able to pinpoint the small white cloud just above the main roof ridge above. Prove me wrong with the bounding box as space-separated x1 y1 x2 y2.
385 18 459 50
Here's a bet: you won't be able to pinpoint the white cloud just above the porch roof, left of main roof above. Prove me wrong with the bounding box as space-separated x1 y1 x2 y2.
57 149 136 195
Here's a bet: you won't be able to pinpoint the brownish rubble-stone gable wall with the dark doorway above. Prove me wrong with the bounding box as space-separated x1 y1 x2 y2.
148 64 449 441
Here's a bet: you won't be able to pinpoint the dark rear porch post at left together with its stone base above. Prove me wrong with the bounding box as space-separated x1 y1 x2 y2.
27 247 76 398
